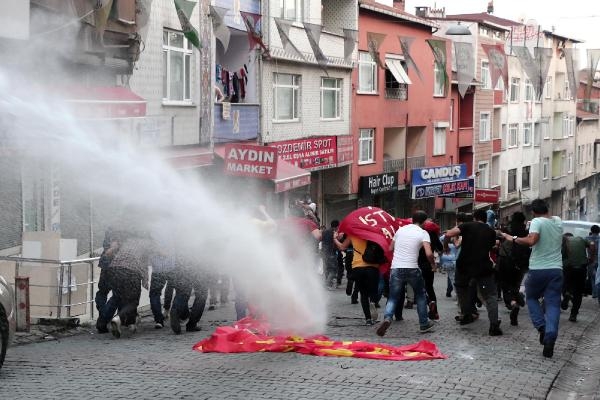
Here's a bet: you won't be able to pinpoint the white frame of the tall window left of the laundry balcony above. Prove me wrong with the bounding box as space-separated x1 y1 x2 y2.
162 29 194 105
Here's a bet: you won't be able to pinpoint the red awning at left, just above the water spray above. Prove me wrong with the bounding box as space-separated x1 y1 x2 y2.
58 86 146 118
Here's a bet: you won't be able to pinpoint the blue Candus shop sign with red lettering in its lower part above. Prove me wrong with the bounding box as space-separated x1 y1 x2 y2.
411 164 470 199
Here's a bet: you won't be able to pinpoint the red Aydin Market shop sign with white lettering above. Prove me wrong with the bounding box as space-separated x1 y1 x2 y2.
224 144 277 179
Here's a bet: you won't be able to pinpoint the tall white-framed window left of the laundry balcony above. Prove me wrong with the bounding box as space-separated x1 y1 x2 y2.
162 30 193 103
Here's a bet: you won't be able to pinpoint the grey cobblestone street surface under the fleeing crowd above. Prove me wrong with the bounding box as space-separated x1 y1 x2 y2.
0 274 600 400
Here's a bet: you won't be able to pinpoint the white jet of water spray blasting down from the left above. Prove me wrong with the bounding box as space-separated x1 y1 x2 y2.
0 65 326 333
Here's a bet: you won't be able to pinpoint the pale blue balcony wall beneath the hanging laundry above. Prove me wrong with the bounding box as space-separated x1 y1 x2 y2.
213 103 260 143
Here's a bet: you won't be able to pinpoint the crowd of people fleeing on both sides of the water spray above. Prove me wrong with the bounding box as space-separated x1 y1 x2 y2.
96 199 600 357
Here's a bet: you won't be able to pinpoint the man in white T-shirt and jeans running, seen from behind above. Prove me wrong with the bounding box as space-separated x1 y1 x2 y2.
377 211 435 336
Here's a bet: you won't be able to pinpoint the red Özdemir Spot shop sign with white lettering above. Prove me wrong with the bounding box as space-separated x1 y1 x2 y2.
269 136 338 171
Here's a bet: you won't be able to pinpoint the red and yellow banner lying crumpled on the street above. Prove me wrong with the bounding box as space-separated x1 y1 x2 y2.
193 318 448 361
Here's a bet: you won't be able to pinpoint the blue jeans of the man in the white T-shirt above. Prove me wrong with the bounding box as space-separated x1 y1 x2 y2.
384 268 429 326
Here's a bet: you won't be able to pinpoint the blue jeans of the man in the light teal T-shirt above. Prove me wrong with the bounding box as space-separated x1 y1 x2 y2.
525 268 563 343
